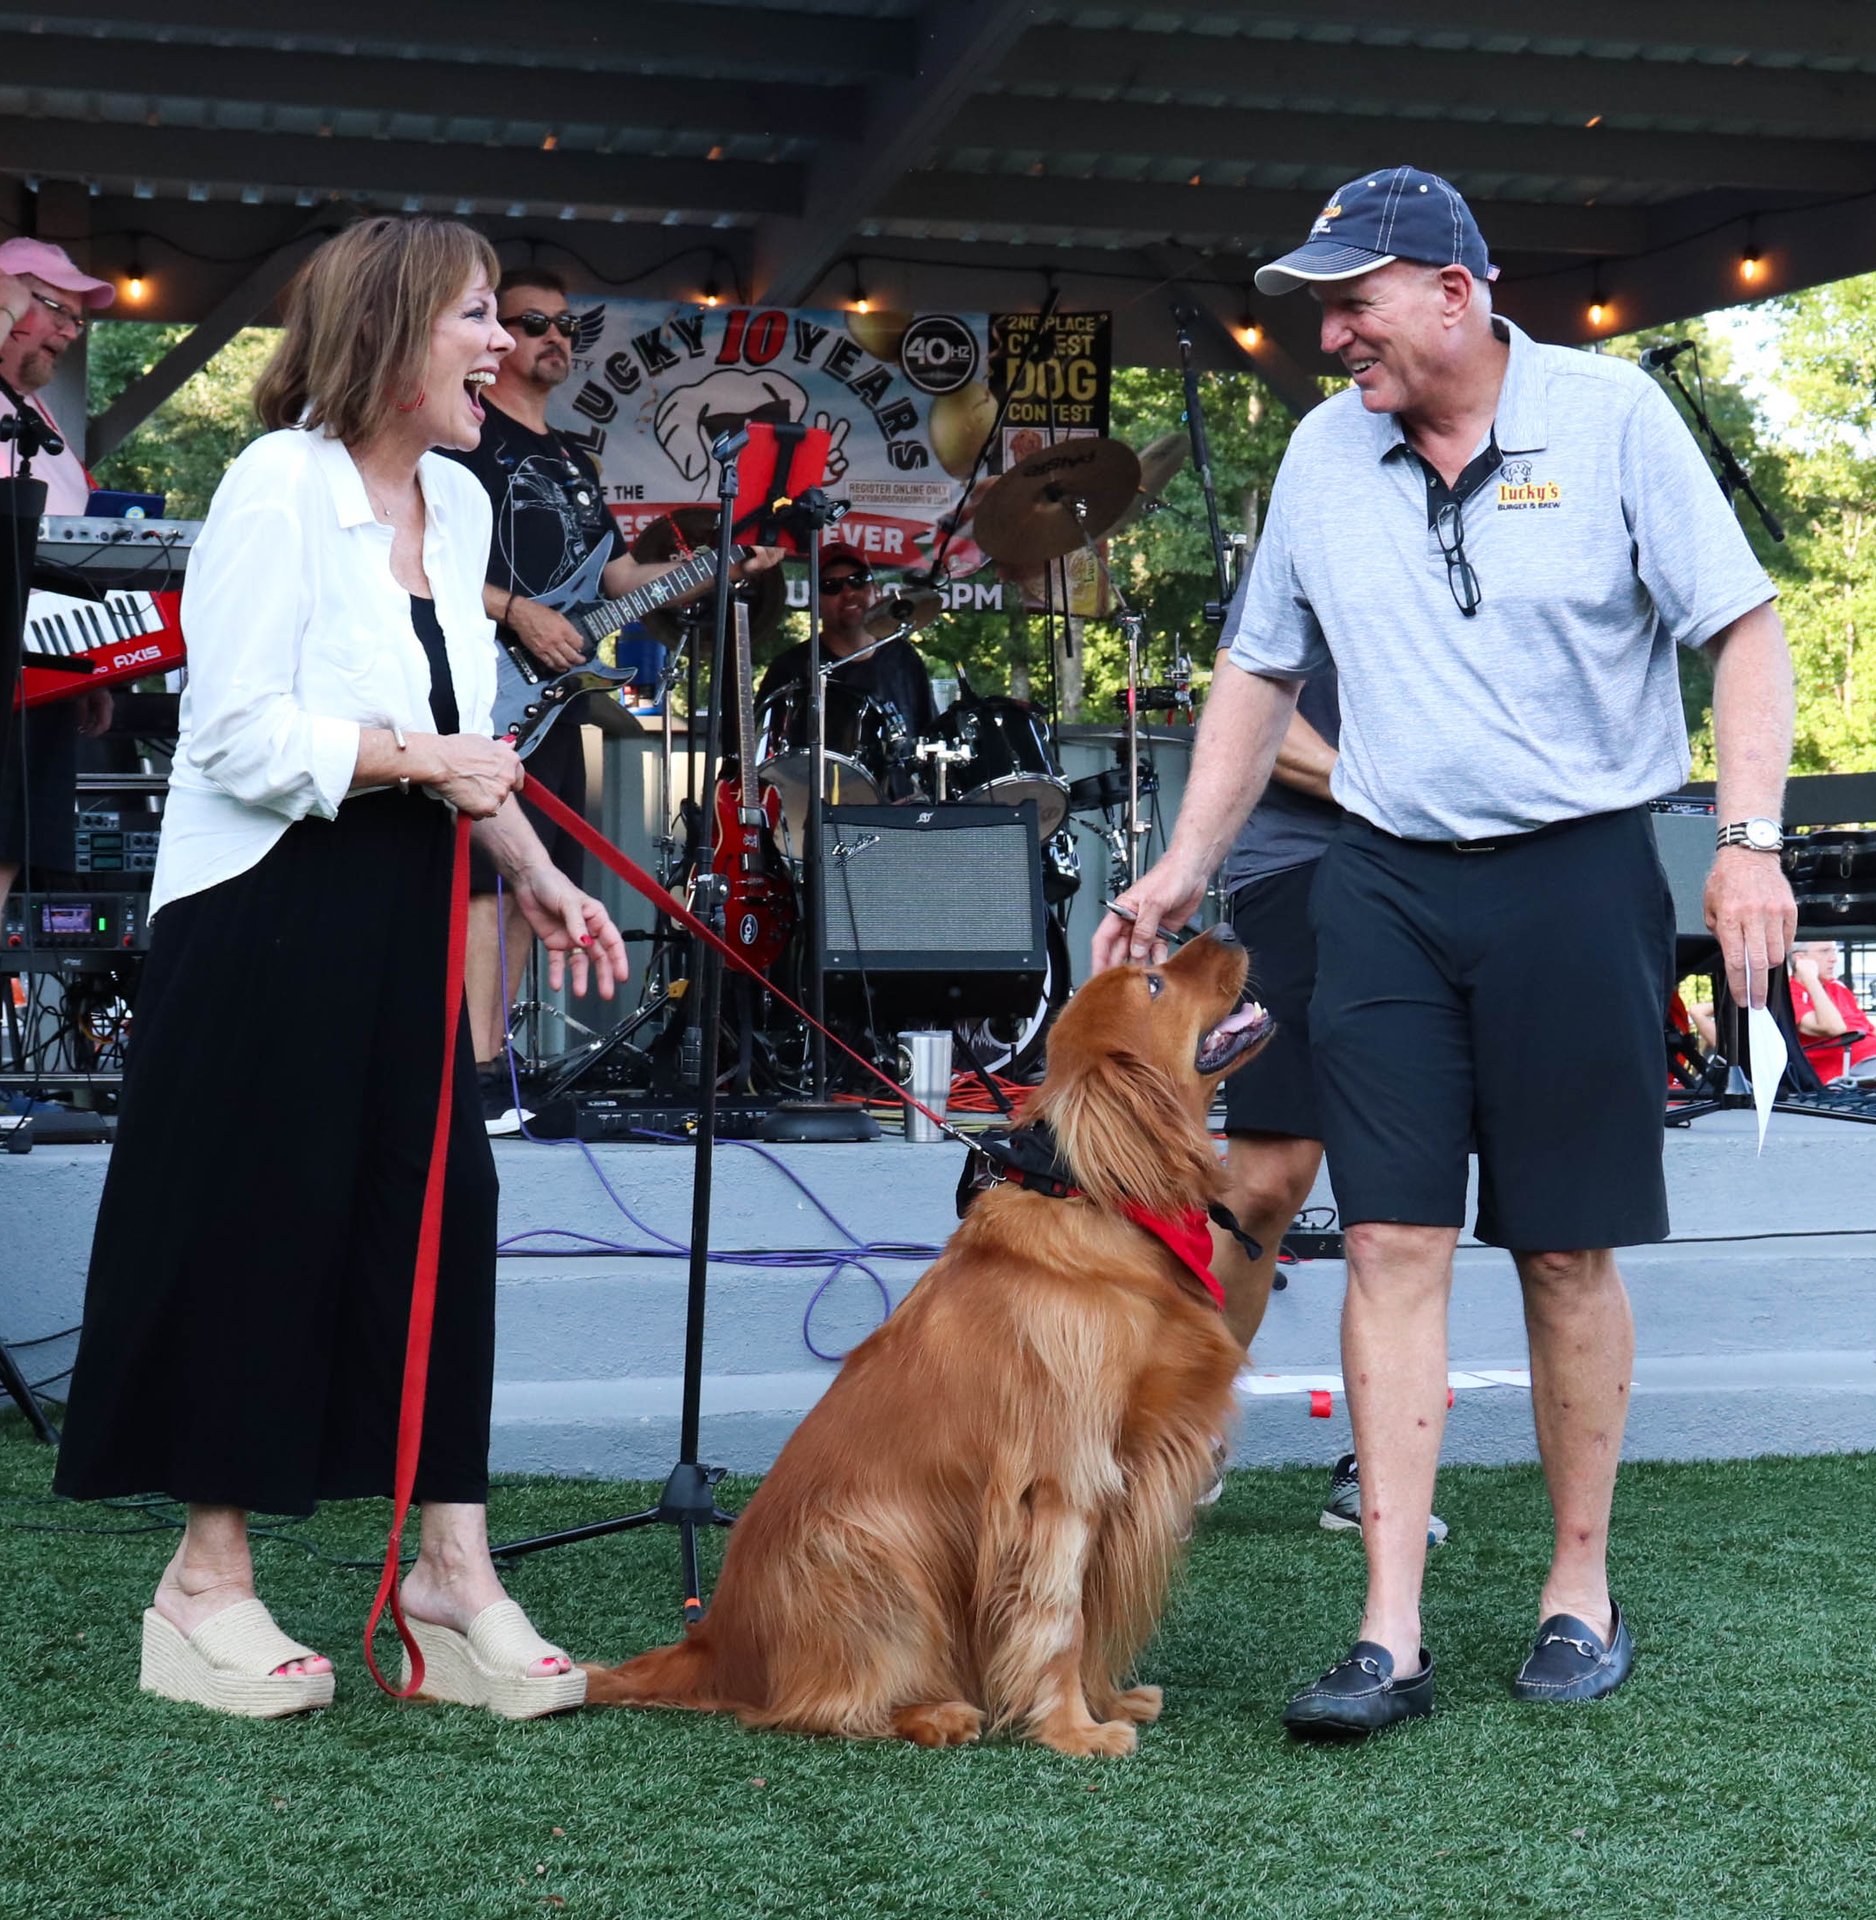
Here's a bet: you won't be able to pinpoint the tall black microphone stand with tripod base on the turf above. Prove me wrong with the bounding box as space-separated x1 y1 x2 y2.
493 430 749 1624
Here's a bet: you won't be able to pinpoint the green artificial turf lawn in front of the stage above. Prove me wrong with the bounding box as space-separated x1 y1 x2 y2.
0 1417 1876 1920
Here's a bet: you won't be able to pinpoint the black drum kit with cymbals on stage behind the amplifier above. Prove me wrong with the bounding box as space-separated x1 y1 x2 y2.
545 434 1187 1096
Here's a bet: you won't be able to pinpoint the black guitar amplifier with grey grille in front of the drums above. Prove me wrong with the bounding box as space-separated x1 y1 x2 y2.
820 801 1048 1027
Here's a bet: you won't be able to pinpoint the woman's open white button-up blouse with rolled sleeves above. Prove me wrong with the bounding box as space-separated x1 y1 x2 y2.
150 428 495 916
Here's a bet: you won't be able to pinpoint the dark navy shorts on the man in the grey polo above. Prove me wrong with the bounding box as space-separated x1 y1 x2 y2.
1310 808 1674 1252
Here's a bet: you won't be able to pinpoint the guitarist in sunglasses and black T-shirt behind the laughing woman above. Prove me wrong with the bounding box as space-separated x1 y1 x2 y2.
453 267 782 1133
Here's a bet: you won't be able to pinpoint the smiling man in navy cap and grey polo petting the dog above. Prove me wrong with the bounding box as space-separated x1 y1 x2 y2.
1094 167 1795 1734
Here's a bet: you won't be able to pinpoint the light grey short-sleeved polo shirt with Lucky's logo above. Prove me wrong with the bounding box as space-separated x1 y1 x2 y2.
1231 317 1774 839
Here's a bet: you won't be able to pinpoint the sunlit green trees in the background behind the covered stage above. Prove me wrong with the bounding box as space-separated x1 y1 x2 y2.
90 275 1876 772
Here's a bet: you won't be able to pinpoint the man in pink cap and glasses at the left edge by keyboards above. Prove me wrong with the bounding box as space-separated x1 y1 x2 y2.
0 236 115 1021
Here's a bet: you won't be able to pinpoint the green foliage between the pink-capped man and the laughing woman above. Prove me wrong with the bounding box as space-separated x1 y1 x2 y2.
86 321 278 520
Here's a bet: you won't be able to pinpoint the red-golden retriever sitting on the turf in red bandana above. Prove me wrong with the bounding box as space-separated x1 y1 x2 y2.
586 929 1271 1755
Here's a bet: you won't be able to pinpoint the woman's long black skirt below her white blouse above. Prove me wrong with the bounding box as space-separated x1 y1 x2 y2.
54 793 495 1513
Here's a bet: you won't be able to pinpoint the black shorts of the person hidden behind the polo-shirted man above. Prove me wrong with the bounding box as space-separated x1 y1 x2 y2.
1225 860 1323 1140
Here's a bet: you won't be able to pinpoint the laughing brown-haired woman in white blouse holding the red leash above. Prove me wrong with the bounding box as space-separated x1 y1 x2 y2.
56 219 626 1718
